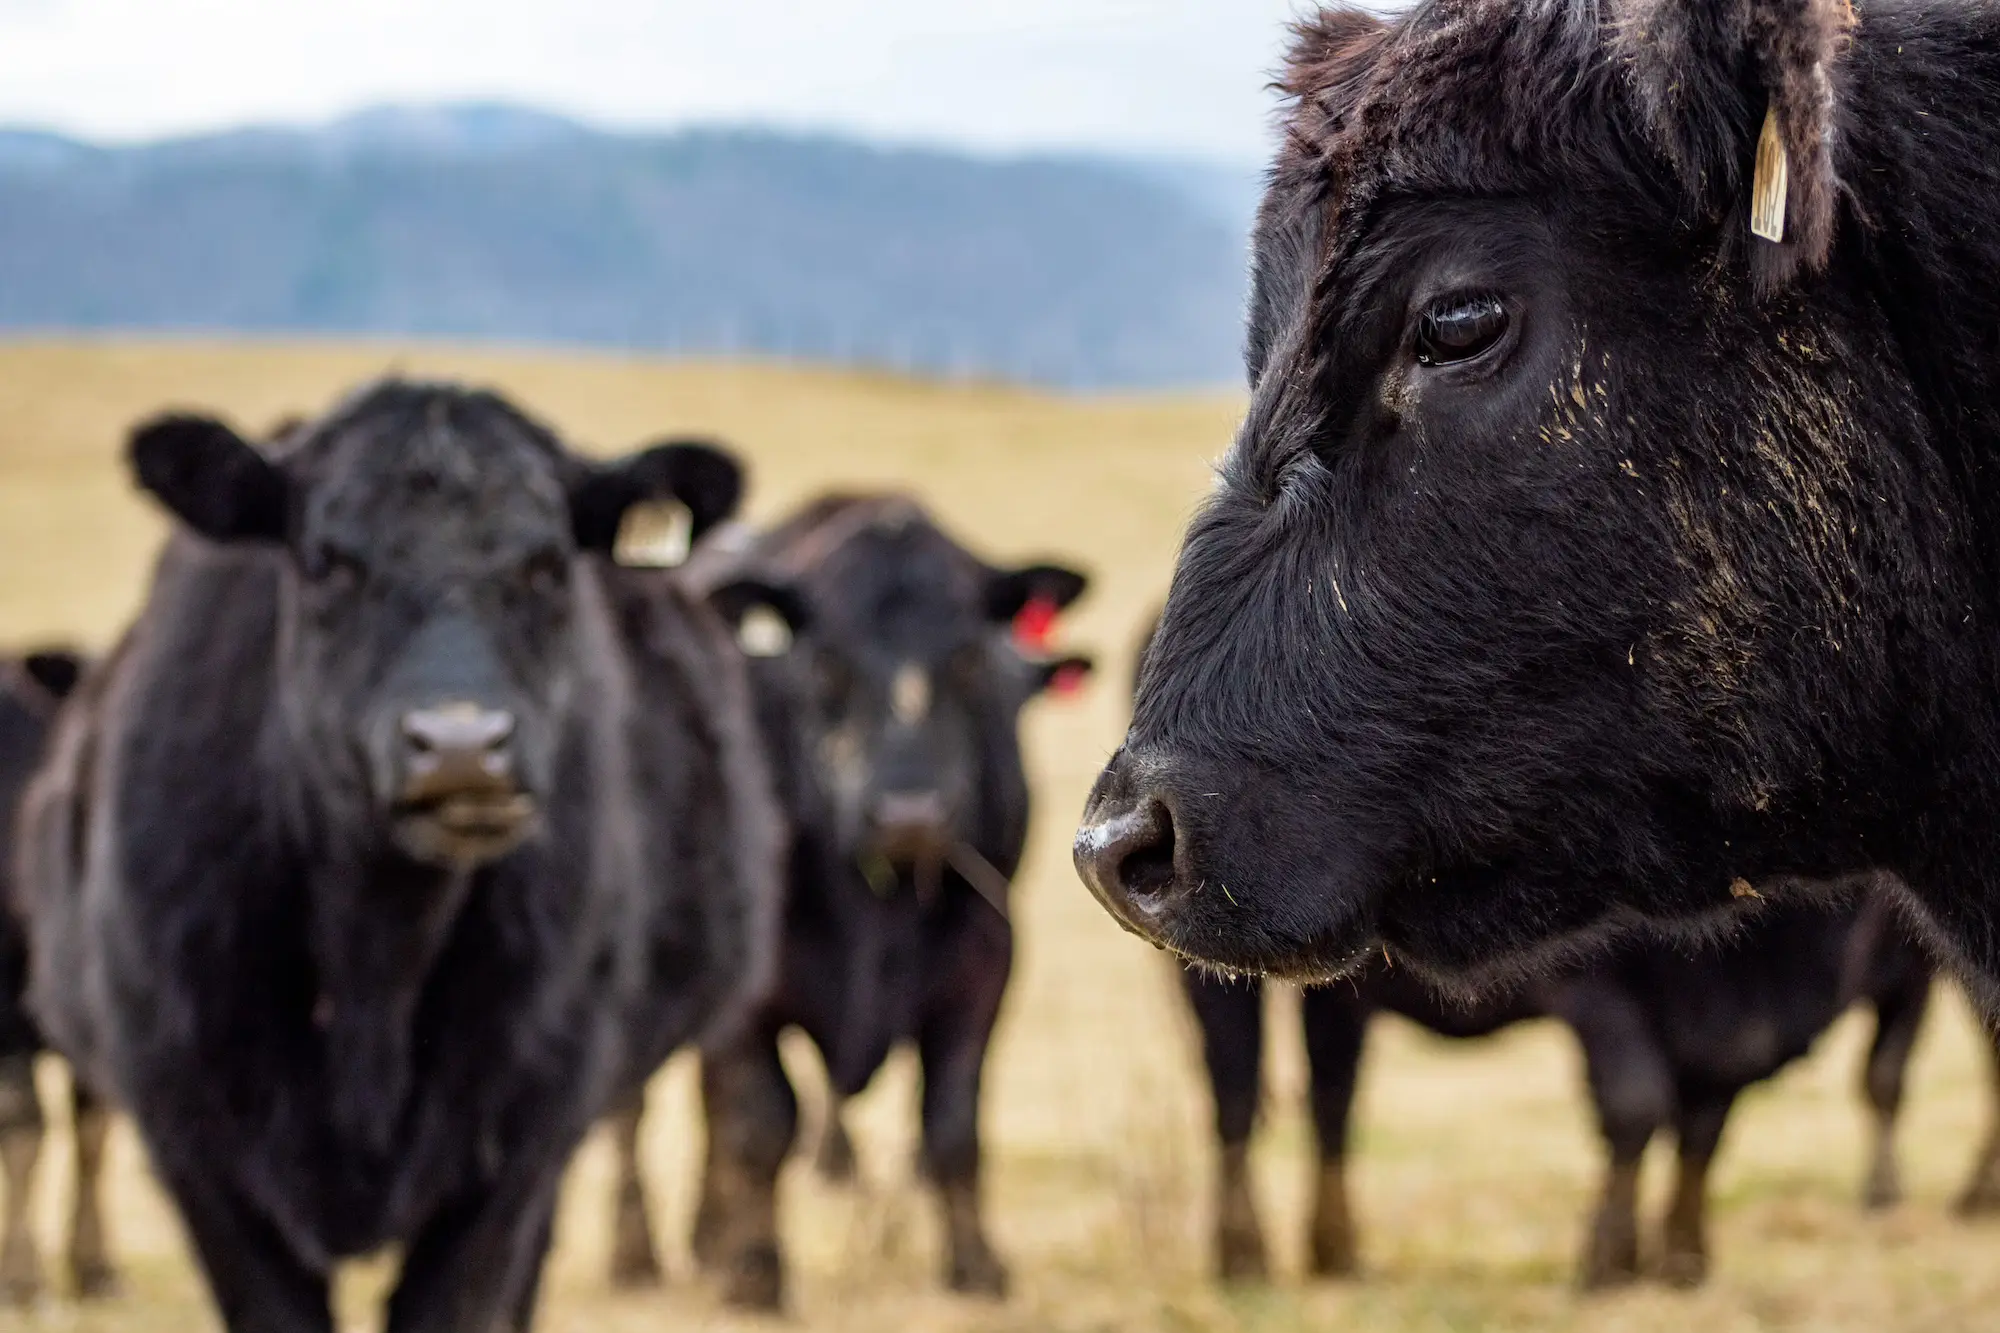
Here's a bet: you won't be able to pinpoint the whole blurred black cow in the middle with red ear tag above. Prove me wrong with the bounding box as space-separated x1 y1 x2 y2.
614 494 1090 1309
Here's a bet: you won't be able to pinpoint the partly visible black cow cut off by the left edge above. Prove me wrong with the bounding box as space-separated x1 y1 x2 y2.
0 648 118 1305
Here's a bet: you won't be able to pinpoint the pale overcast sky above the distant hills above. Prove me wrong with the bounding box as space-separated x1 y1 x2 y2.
0 0 1344 160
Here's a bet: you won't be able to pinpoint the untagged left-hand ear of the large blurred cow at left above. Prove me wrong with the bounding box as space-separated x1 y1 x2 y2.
126 414 290 542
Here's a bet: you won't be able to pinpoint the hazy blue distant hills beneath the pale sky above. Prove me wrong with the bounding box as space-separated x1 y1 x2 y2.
0 106 1254 386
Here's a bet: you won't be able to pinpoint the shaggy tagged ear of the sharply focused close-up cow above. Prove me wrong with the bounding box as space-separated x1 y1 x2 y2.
1612 0 1854 292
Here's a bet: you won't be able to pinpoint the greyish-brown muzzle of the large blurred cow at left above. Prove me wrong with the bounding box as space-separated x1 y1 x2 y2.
384 703 538 867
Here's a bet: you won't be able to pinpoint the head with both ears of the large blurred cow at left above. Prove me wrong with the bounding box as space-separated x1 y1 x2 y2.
132 382 740 869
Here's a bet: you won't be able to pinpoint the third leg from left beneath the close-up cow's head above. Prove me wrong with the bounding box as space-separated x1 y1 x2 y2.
1554 981 1674 1289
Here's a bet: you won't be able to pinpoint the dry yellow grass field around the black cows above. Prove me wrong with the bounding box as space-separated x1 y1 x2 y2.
0 334 2000 1333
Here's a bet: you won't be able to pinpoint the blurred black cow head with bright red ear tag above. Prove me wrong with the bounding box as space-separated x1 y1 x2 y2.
718 498 1090 873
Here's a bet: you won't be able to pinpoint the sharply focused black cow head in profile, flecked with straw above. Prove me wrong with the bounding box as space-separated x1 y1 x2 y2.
1076 0 1956 977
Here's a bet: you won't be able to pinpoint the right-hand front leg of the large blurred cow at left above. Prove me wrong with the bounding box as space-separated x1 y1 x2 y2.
384 1153 568 1333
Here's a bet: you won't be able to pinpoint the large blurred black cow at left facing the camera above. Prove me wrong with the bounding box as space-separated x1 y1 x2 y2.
20 380 782 1333
